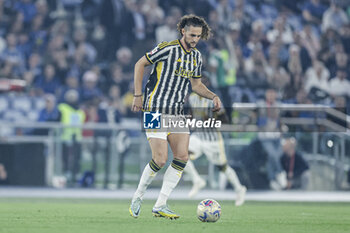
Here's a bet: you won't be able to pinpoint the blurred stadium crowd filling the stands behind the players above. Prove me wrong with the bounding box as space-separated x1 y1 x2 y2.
0 0 350 123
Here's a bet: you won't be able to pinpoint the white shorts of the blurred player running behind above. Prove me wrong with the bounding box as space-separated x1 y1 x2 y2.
188 135 227 165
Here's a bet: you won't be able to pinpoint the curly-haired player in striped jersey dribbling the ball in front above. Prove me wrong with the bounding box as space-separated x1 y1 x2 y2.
129 15 221 219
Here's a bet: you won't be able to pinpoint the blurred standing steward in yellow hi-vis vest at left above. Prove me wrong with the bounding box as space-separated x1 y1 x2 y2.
58 90 86 186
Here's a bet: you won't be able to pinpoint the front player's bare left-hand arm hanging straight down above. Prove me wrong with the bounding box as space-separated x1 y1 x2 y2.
131 56 151 112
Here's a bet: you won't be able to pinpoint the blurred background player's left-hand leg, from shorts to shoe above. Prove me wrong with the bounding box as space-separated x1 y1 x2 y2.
184 135 206 197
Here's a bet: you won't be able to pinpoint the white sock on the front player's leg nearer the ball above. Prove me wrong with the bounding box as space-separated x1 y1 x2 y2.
154 165 183 207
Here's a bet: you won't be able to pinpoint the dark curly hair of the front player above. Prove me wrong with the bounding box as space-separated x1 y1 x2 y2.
177 14 211 40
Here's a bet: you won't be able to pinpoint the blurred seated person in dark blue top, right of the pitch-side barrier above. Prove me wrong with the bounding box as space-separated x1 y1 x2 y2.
281 138 311 190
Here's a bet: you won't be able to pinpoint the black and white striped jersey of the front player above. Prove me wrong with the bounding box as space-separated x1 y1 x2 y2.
143 40 202 115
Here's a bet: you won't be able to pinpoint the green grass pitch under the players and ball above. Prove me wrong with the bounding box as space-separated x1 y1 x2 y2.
0 198 350 233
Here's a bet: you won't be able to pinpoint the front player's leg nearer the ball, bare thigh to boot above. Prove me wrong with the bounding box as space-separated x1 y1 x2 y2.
152 133 189 219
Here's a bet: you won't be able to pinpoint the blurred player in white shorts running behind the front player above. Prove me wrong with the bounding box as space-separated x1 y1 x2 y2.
185 81 247 206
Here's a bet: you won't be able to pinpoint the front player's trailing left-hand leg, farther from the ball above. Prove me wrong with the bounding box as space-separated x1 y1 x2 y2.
129 134 168 218
